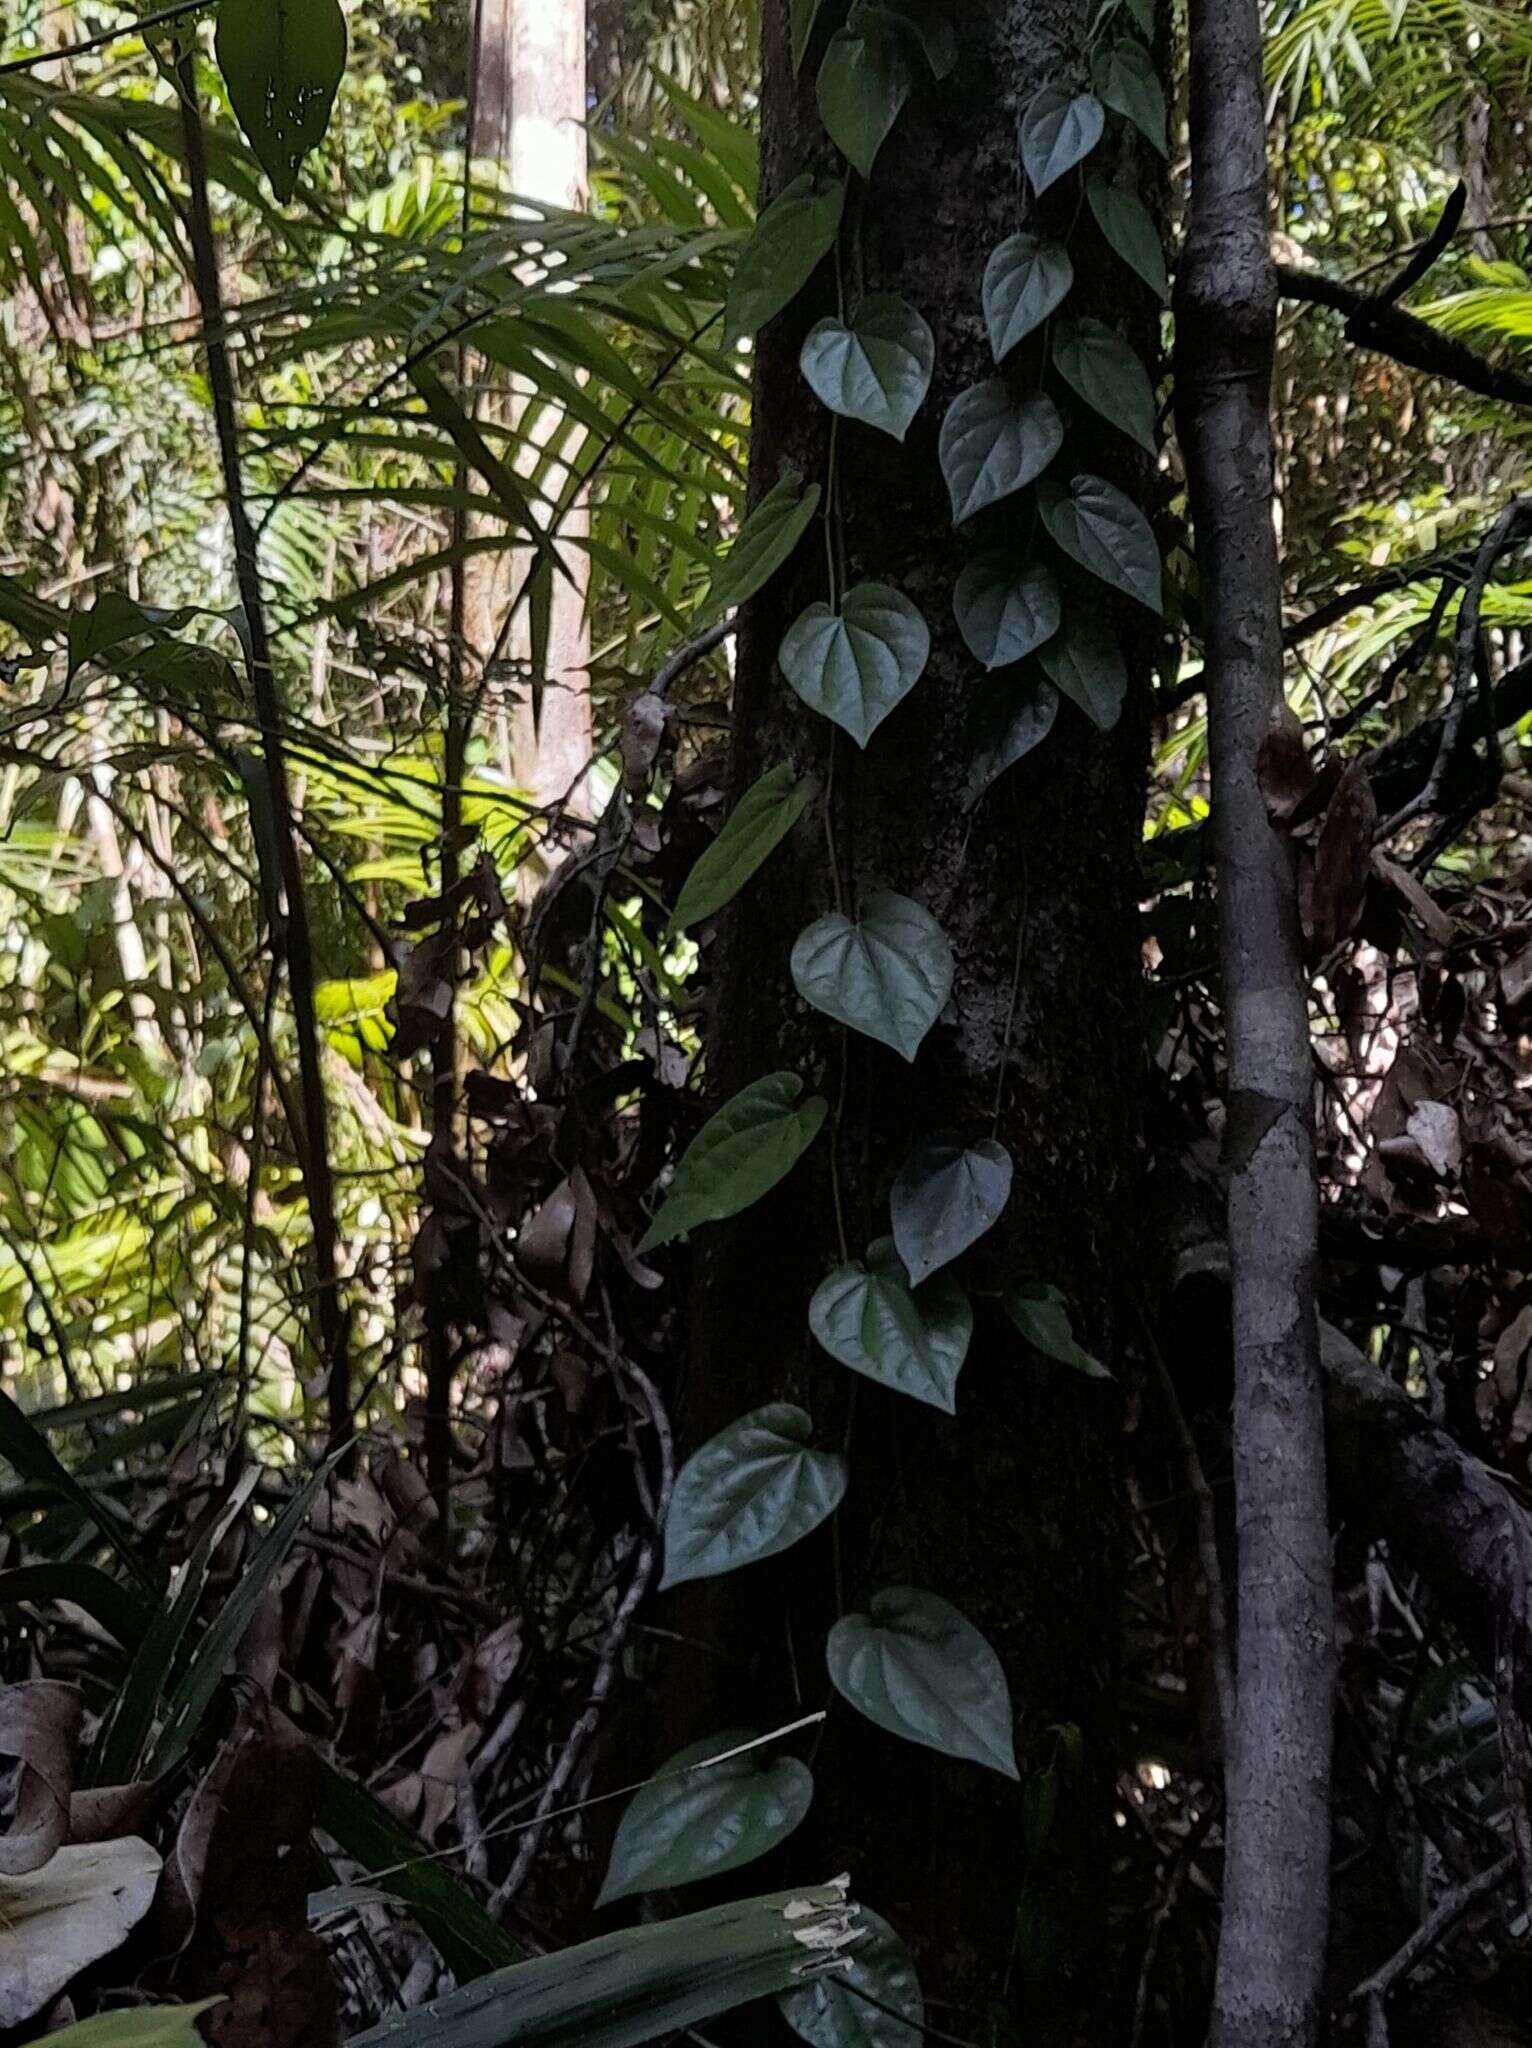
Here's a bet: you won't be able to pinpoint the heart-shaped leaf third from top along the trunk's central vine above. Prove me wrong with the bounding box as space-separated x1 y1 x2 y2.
776 584 932 748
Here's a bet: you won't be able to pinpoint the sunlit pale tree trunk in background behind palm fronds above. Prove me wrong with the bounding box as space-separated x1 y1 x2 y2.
467 0 592 813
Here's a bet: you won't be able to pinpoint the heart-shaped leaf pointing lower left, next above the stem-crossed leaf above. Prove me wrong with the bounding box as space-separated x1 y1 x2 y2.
659 1401 846 1589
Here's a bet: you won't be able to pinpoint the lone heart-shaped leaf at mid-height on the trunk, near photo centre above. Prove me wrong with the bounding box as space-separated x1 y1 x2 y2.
793 891 952 1059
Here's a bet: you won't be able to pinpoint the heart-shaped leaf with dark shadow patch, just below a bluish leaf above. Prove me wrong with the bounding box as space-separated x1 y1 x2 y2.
809 1237 973 1415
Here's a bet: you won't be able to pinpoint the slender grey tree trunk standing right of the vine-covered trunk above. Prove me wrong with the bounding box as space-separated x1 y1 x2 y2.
1176 0 1331 2048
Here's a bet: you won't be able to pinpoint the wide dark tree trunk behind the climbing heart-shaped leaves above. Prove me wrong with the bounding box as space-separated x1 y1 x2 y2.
659 0 1155 2048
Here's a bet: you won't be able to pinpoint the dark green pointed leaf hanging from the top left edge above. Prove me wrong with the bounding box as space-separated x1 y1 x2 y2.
213 0 346 205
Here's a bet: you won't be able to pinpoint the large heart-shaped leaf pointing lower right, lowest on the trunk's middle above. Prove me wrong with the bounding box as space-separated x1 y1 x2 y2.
825 1585 1020 1778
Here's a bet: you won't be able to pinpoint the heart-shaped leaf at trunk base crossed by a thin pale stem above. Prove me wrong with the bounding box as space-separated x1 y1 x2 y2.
596 1729 813 1907
